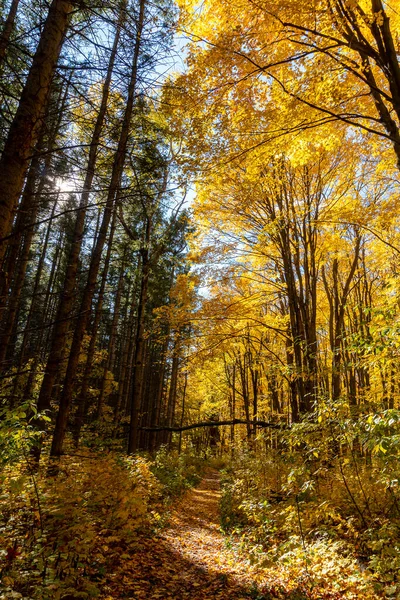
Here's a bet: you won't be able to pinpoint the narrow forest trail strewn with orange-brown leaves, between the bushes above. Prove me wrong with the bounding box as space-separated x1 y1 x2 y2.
101 469 268 600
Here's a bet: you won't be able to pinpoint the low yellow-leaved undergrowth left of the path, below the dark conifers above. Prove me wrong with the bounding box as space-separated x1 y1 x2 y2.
0 449 200 600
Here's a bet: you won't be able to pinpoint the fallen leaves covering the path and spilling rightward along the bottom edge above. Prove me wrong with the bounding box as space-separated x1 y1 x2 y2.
102 470 378 600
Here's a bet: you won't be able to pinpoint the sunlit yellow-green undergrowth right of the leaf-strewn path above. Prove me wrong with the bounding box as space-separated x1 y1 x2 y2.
221 411 400 599
